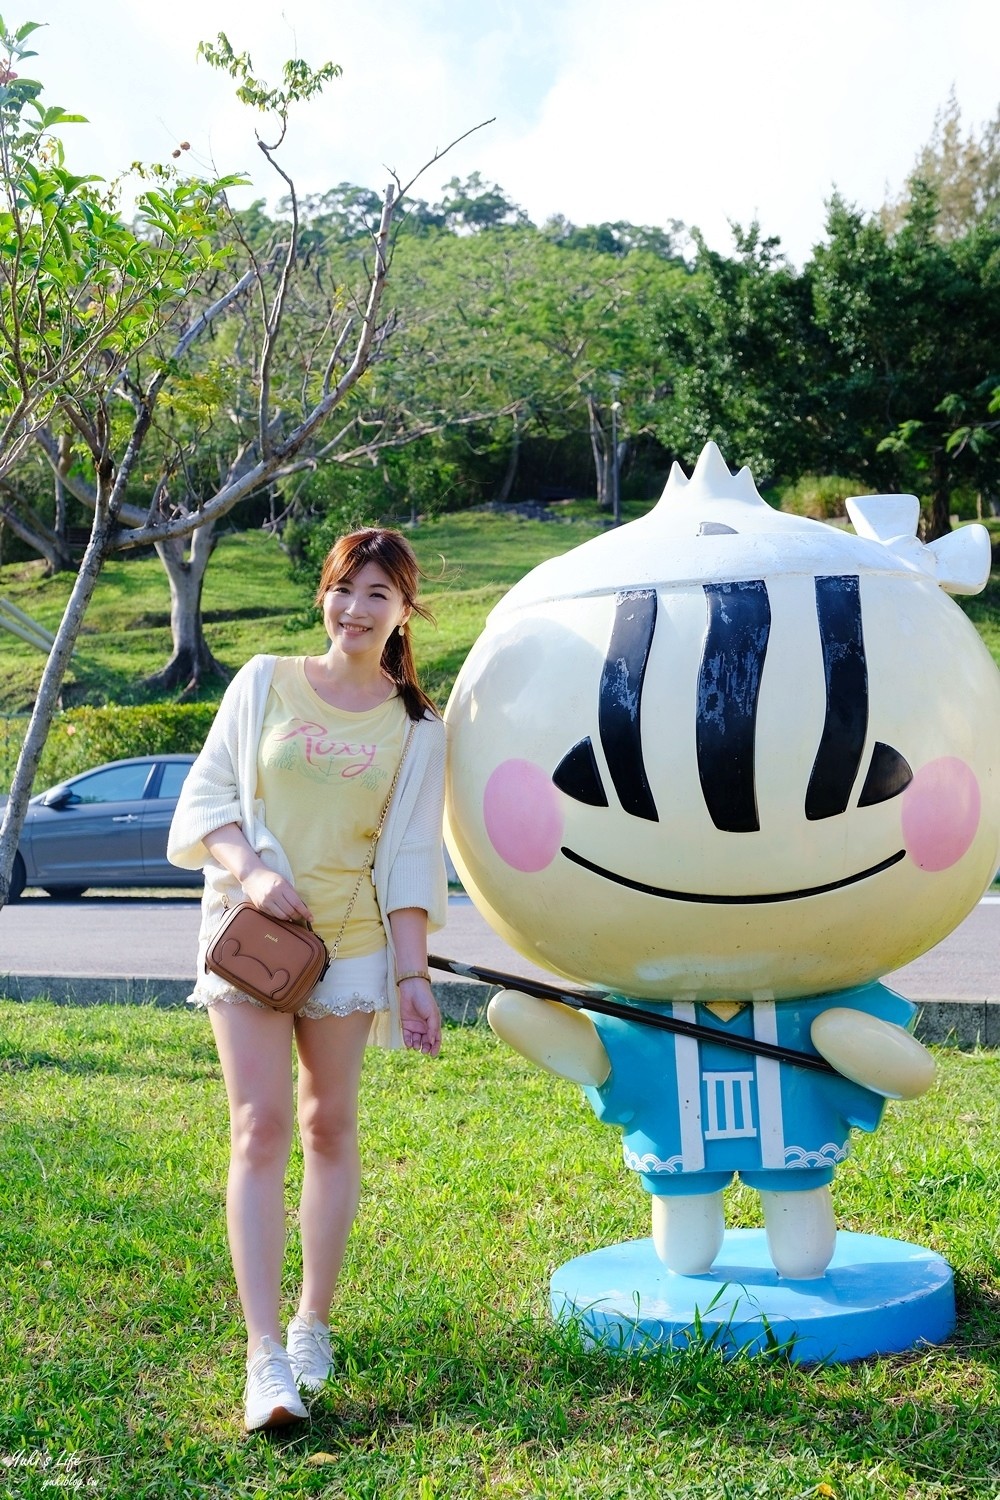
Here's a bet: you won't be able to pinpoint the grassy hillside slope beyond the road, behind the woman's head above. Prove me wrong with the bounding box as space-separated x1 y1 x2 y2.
0 504 1000 716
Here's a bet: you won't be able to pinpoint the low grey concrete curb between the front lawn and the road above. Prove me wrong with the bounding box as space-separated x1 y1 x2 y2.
0 974 1000 1052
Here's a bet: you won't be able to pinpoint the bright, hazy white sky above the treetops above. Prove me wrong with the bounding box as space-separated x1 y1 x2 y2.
13 0 1000 266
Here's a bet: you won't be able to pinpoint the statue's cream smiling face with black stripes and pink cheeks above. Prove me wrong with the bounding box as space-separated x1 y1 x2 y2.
447 534 1000 999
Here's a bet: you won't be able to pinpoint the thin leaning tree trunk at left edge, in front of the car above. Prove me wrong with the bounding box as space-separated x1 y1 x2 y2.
0 498 111 908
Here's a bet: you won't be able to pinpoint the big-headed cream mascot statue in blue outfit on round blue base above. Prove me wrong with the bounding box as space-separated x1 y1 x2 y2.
447 444 1000 1358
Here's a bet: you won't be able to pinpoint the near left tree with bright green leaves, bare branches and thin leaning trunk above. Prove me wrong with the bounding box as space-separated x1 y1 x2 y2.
0 24 446 905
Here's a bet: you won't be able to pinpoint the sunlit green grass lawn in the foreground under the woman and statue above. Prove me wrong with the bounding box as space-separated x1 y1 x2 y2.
0 1002 1000 1500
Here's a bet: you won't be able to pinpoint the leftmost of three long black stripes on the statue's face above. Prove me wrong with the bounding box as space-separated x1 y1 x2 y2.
597 588 660 824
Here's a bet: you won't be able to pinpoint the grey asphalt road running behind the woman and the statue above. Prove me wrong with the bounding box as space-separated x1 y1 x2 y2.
0 891 1000 1004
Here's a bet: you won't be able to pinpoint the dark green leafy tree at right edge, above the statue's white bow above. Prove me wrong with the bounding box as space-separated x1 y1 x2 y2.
810 185 1000 537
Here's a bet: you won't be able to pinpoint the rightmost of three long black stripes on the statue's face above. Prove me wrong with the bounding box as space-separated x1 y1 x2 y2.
805 575 868 821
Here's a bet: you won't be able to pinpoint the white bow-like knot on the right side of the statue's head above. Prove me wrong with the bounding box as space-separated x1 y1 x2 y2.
846 495 991 594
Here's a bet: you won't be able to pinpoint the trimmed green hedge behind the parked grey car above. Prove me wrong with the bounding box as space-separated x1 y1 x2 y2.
0 704 219 792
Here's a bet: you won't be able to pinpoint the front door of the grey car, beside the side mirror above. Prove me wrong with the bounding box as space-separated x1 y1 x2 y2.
30 761 154 890
